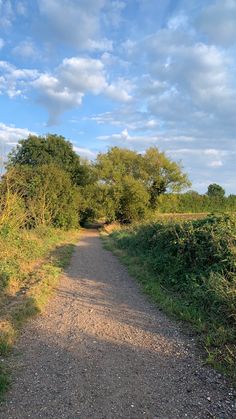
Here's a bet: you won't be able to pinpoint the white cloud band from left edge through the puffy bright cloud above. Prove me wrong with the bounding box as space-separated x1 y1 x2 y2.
0 57 133 125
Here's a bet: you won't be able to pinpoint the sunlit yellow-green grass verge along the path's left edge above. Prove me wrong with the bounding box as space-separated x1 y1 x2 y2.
0 228 78 398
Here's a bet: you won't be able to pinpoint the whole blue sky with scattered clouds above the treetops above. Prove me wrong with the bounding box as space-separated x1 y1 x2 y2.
0 0 236 194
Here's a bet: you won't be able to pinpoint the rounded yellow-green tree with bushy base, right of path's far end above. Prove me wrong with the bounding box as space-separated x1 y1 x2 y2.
90 147 189 223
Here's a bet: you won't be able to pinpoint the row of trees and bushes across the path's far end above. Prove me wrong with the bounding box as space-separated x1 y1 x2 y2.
0 134 234 229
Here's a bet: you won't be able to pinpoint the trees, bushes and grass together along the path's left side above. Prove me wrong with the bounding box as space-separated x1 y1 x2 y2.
0 136 82 394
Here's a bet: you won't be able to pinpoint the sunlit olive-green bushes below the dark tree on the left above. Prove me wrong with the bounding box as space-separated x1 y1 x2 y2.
1 163 80 229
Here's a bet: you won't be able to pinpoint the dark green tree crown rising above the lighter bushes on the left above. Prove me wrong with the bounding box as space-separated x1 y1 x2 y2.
7 134 90 186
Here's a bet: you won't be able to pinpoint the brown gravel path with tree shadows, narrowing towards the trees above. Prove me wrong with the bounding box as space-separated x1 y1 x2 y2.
0 231 236 419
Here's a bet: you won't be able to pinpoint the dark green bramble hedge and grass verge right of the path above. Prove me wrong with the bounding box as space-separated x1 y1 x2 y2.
104 216 236 388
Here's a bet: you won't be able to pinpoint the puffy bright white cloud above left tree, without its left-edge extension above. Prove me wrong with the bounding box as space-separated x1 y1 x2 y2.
32 57 130 124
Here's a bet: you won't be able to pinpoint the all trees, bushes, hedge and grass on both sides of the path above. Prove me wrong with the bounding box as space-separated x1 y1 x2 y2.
0 134 236 392
